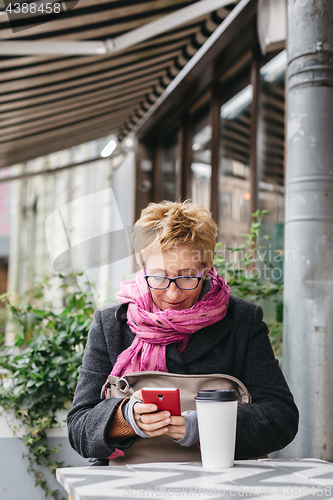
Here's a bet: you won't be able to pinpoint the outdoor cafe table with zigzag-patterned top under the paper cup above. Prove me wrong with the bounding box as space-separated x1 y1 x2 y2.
57 458 333 500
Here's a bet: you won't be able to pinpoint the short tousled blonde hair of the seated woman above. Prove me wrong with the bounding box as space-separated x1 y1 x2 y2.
132 200 217 271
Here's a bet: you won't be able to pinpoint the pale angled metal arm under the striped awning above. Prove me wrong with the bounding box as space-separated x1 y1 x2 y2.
0 0 237 56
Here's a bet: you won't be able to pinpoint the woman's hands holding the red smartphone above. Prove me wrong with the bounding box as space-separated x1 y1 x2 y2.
133 391 185 440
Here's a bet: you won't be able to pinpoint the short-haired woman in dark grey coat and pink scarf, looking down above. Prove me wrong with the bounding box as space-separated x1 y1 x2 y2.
68 201 298 464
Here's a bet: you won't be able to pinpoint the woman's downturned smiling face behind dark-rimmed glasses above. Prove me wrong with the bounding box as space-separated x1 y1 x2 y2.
145 245 206 311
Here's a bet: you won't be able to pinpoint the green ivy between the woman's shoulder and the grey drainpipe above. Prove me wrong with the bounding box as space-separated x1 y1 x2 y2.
214 210 283 356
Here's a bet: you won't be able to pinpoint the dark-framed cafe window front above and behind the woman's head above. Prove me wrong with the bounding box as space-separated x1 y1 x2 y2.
136 2 287 288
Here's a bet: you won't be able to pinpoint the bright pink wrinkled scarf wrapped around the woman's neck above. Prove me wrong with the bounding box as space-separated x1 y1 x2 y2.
111 267 230 376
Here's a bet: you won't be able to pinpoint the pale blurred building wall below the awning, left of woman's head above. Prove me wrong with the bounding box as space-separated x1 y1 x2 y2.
7 139 135 342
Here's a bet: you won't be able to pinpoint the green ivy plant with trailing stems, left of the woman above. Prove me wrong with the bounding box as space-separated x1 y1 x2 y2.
0 282 94 499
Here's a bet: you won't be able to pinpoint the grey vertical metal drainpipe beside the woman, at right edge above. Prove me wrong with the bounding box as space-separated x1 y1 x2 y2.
283 0 333 461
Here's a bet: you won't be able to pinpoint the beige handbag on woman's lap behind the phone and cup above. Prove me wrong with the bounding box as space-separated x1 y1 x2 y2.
101 371 251 465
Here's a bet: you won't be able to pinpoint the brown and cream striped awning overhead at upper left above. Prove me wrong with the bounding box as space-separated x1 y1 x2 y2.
0 0 238 168
